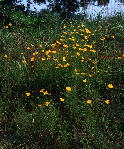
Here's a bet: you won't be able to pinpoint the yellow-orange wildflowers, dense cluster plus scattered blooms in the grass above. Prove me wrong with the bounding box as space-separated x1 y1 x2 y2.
3 23 121 110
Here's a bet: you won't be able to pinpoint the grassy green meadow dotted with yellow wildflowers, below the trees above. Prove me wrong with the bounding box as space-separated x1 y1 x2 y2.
0 12 124 149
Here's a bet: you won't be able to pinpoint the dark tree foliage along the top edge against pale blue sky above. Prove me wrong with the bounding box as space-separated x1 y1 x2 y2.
0 0 123 23
